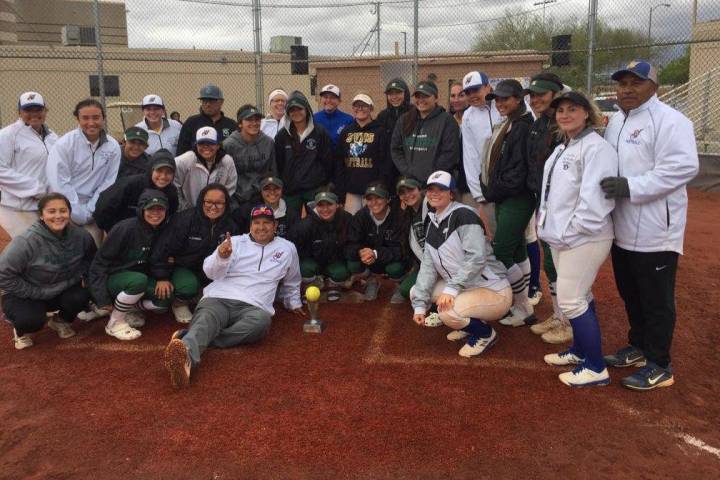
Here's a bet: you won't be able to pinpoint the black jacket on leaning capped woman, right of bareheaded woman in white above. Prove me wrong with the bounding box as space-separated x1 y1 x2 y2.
93 155 178 232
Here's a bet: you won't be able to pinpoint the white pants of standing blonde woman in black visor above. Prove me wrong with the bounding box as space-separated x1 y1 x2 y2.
550 240 612 319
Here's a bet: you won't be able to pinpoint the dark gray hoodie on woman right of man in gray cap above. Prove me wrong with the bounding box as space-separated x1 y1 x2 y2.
223 130 277 203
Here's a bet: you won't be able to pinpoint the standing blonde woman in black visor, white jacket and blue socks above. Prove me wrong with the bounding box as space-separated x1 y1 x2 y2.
537 92 618 387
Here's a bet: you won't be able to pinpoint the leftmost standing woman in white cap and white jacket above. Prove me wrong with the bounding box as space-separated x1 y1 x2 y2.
0 92 58 239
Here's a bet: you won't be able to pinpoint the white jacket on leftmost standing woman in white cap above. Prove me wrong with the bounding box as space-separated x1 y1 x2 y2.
0 119 58 211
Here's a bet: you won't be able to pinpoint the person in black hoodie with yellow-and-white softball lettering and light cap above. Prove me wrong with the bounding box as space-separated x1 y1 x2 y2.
335 93 394 215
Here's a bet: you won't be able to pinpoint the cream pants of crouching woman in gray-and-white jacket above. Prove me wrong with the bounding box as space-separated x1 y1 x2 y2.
410 280 512 330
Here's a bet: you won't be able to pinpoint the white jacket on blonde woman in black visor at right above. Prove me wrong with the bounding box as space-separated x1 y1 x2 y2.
537 129 618 250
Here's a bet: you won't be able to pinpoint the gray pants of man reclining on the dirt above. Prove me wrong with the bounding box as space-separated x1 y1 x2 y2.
182 298 272 365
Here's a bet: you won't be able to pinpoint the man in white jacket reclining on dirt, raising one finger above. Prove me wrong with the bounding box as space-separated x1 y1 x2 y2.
165 205 305 388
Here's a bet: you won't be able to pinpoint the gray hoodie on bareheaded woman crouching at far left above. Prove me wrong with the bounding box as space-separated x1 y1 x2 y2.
0 220 97 300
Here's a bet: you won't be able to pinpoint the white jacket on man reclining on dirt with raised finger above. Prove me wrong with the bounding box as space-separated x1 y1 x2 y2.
203 233 302 315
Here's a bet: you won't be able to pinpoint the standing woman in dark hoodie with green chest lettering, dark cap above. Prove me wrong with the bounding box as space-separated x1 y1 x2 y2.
391 81 460 185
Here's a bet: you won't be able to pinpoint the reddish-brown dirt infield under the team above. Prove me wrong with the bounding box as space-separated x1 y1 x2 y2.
0 191 720 479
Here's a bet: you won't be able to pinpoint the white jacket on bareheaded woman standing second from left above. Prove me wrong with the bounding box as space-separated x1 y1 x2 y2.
46 127 121 225
